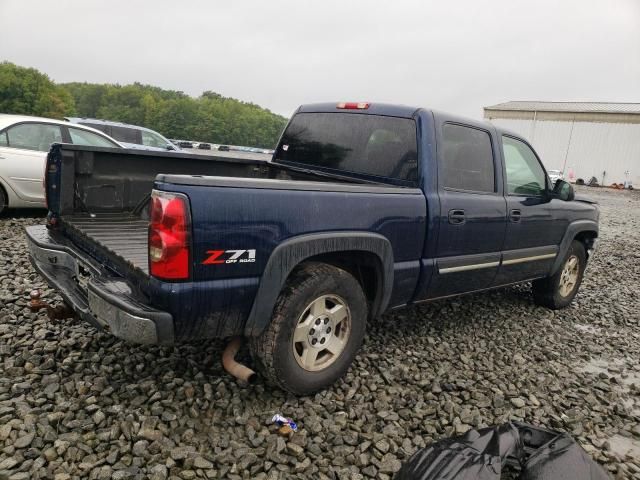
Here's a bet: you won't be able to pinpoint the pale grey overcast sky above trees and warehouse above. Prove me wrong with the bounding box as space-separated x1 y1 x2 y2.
0 0 640 118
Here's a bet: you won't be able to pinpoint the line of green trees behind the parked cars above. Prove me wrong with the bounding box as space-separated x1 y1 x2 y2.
0 62 287 148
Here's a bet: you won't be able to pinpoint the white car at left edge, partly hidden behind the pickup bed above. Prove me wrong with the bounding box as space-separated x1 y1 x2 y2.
0 114 122 213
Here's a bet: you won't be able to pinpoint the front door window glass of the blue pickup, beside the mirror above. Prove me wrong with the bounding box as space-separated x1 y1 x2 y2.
502 136 547 196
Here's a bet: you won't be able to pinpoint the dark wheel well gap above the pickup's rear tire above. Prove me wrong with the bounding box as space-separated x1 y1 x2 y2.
301 251 384 316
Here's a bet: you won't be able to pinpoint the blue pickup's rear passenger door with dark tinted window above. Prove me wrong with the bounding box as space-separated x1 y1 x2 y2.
426 121 506 298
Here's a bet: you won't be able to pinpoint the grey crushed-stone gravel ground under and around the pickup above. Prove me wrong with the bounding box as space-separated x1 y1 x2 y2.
0 187 640 480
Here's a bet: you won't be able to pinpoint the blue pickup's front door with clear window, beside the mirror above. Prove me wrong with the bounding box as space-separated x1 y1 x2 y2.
496 135 567 284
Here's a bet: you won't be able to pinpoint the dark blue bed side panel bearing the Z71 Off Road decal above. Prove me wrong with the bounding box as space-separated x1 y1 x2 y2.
159 184 425 281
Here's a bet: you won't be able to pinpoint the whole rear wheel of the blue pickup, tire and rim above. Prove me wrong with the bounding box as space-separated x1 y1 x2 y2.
250 263 367 395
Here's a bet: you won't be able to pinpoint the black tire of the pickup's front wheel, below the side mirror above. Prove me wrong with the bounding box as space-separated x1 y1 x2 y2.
533 240 587 310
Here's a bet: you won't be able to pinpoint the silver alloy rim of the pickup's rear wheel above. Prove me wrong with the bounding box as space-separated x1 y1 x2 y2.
292 295 351 372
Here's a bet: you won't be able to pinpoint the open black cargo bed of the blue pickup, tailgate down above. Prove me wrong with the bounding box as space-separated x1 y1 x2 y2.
47 145 376 278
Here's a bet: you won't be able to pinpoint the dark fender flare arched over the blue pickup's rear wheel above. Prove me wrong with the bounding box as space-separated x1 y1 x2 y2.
244 232 393 336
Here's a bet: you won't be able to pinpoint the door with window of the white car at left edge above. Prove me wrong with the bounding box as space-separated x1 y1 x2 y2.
0 122 62 203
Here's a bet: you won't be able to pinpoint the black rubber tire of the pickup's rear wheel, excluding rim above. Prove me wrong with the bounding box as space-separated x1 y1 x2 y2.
249 263 368 395
